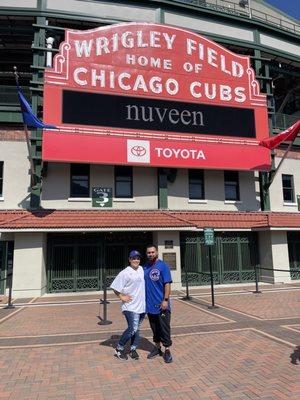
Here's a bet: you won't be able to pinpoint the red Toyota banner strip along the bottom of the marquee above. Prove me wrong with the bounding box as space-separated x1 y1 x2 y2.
43 131 269 170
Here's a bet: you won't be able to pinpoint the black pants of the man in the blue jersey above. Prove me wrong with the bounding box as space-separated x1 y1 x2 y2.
148 310 172 347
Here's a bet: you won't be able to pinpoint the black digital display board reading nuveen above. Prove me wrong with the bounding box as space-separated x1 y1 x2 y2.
62 90 256 138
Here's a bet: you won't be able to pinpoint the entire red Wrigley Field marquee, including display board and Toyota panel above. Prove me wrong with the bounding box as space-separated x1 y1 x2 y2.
43 23 270 170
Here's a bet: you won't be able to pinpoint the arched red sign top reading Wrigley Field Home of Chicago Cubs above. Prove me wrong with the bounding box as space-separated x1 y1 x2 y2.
45 23 266 107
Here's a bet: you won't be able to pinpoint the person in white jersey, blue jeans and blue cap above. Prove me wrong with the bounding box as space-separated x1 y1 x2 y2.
110 250 146 360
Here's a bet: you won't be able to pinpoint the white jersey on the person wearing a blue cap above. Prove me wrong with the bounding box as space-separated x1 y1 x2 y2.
110 266 146 314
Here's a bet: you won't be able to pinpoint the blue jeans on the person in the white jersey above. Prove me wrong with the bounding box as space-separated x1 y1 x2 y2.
117 311 145 350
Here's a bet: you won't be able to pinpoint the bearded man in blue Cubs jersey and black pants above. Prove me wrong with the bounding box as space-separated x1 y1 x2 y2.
144 244 173 363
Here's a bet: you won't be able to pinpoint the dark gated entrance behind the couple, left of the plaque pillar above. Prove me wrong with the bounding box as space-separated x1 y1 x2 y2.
47 232 152 292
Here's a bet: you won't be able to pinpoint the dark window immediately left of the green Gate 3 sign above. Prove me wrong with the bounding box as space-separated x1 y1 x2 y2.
70 164 90 197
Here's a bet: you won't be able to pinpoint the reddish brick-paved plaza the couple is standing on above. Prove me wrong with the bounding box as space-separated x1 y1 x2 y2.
0 283 300 400
